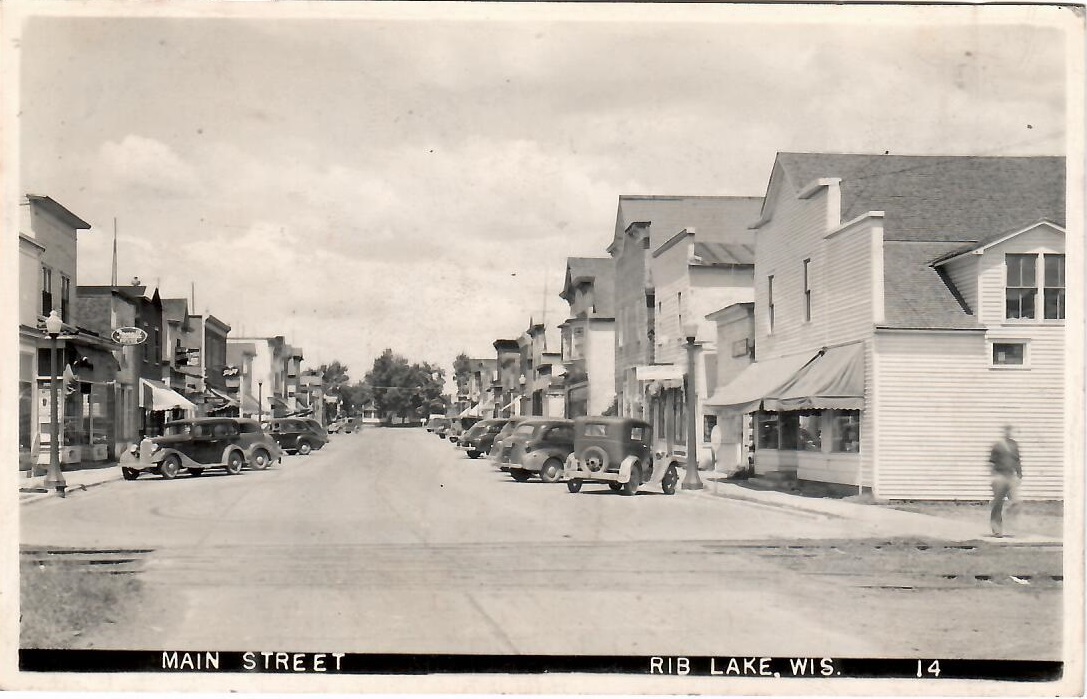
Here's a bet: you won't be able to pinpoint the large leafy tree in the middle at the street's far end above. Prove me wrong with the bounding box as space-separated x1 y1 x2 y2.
363 349 447 420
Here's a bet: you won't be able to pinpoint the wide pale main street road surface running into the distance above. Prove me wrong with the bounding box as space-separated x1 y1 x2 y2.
21 428 1062 659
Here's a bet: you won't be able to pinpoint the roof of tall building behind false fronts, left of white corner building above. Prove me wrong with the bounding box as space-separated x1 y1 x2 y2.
609 195 762 250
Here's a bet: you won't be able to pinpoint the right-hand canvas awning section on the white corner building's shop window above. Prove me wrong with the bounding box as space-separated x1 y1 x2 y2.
762 342 864 411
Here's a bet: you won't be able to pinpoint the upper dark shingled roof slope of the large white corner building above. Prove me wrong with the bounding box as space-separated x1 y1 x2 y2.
777 153 1065 242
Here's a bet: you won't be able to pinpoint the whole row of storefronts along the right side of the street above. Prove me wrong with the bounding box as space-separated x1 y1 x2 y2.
452 153 1078 500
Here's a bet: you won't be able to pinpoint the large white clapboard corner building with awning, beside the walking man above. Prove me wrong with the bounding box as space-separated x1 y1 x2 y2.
709 153 1065 500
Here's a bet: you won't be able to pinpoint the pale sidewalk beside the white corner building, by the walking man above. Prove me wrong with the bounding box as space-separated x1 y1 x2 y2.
694 472 1062 546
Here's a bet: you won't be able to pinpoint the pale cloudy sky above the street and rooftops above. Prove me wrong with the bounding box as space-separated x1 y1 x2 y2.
8 3 1069 377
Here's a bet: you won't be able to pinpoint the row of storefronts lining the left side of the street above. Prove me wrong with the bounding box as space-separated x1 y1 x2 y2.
18 195 326 472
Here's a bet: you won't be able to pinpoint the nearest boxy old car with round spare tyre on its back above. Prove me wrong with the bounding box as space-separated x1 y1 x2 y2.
563 416 679 496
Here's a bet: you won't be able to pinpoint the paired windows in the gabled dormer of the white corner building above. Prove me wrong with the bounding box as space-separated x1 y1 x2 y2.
1004 253 1064 321
